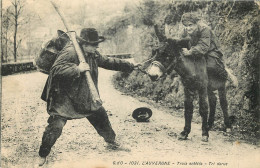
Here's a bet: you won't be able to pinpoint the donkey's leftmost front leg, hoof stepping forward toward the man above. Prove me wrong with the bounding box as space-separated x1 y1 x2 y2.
178 88 193 140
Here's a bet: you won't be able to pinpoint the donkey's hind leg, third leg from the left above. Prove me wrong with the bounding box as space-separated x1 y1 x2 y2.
208 90 217 129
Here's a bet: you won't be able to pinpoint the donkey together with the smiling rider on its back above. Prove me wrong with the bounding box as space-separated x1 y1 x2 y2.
148 13 238 141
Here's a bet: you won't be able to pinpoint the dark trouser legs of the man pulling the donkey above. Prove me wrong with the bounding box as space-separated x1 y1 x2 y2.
39 107 116 157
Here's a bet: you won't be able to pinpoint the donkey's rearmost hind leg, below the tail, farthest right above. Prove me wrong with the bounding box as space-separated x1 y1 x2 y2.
218 87 231 131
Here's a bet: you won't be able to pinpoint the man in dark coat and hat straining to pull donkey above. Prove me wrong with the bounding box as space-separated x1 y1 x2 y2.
39 28 134 166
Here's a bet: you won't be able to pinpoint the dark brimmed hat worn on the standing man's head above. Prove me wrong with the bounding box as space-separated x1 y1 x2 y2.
77 28 105 45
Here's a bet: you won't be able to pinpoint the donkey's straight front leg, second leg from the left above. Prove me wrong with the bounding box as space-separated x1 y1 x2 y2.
199 87 209 142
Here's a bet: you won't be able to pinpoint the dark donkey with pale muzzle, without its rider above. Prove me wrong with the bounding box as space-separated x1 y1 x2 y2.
147 39 236 142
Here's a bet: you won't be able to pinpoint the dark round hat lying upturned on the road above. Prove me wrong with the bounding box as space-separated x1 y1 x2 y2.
132 107 152 121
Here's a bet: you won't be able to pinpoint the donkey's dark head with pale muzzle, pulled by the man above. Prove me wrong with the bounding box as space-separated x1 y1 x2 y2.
147 39 189 81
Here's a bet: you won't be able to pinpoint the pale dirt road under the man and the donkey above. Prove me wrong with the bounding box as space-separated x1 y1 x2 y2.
1 69 260 168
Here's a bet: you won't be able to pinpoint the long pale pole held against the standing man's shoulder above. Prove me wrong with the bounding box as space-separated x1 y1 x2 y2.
51 1 102 110
